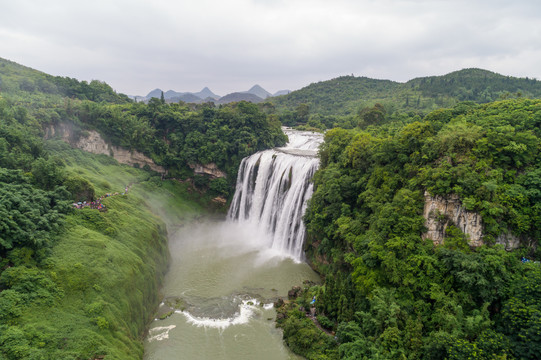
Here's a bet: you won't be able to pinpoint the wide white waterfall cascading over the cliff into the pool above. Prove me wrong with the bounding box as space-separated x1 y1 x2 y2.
228 128 323 260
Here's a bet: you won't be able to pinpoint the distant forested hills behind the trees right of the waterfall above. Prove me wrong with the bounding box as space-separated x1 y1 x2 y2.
271 69 541 115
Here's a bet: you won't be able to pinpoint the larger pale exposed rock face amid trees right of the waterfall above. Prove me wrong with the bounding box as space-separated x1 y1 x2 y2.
423 191 483 247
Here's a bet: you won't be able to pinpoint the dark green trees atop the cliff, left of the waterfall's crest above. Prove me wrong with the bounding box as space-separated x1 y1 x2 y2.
77 98 287 181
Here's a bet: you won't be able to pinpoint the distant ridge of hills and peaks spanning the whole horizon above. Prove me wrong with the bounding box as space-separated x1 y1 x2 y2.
0 58 541 111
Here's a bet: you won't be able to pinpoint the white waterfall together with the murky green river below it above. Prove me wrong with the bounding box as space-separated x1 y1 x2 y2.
144 131 321 360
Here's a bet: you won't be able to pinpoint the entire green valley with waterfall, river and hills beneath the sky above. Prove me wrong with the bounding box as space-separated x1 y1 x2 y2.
0 59 541 360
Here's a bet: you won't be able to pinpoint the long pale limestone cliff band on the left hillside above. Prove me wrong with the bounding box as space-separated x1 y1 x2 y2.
45 124 166 174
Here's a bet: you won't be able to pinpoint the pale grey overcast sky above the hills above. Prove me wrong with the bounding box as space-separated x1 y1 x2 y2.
0 0 541 95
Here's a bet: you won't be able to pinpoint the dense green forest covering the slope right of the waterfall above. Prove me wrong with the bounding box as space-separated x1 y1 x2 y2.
305 99 541 359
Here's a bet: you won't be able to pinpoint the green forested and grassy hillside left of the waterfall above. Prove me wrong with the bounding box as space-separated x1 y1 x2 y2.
0 60 287 360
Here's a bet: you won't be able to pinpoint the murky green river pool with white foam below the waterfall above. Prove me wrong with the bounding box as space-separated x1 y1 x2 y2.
144 222 319 360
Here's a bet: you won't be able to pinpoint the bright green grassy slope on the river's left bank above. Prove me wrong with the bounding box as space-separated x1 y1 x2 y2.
0 141 209 359
